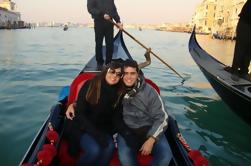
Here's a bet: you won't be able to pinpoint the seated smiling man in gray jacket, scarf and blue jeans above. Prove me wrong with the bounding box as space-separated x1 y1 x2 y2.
115 60 172 166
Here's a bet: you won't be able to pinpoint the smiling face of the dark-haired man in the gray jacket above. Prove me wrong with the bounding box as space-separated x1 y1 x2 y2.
123 67 139 87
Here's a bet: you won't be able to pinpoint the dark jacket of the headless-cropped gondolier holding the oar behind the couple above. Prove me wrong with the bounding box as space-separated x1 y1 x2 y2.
87 0 120 23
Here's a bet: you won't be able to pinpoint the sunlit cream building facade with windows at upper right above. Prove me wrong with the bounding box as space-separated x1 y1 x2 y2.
191 0 247 39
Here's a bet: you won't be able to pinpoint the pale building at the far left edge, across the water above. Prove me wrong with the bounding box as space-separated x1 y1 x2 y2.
0 0 21 28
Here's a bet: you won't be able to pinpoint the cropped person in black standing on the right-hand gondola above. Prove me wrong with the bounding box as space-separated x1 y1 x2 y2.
232 0 251 81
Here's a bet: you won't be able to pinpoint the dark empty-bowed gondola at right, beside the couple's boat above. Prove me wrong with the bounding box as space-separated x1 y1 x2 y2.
189 28 251 124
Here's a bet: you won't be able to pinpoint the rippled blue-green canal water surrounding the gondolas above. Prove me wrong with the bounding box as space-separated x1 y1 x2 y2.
0 28 251 166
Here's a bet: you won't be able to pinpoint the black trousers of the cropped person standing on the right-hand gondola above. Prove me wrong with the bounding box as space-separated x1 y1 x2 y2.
232 20 251 75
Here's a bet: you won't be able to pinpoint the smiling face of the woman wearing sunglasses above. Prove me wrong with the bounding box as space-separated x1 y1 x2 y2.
105 68 122 85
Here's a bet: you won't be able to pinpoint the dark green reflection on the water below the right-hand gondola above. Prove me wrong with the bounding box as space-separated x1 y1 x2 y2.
184 97 251 165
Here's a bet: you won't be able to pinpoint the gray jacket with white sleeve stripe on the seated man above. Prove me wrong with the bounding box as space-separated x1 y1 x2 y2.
122 78 168 138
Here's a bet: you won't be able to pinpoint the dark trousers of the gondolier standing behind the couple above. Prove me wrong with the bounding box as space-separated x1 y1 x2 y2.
94 19 113 65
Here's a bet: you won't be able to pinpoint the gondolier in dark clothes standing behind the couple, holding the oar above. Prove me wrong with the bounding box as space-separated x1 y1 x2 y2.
87 0 123 70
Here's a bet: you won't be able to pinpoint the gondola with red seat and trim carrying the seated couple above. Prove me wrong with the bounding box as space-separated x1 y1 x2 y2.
19 31 208 166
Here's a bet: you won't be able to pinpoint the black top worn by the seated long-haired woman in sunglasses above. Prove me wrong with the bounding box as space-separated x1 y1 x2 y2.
65 81 118 155
